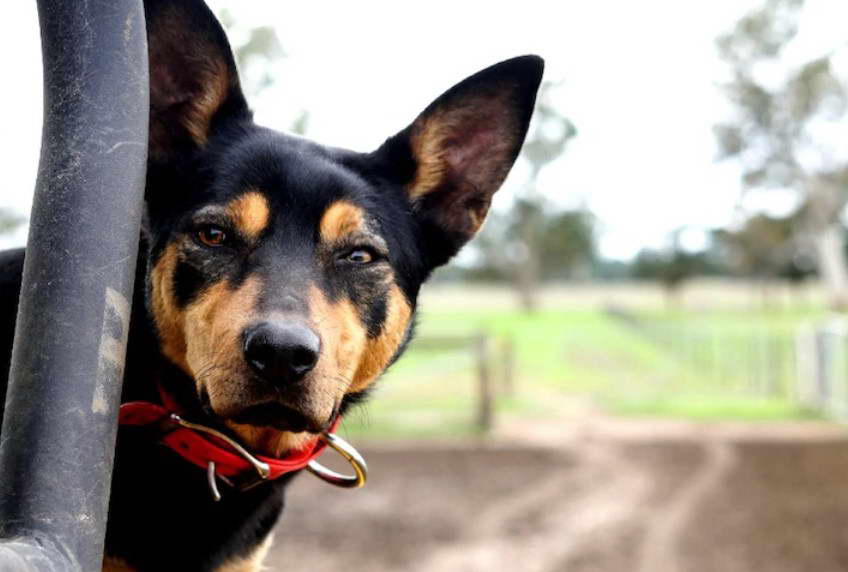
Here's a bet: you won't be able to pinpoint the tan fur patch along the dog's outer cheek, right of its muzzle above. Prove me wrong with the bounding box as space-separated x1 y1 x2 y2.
349 285 412 392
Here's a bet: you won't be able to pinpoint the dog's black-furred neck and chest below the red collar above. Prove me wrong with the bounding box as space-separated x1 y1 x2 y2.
106 418 293 570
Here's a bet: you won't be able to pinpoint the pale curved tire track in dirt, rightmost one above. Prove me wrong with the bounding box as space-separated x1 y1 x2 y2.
637 439 737 572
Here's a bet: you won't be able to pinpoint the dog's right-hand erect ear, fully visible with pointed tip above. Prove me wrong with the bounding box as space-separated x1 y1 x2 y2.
377 56 544 267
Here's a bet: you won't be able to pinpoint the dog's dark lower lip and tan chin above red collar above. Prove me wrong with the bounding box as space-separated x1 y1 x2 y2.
219 403 325 457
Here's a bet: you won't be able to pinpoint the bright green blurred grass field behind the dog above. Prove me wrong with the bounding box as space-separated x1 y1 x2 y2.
338 284 820 438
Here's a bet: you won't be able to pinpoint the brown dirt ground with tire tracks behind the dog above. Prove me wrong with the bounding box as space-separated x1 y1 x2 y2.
268 419 848 572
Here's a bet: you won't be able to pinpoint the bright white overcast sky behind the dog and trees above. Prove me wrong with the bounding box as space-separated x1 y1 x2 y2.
0 0 848 258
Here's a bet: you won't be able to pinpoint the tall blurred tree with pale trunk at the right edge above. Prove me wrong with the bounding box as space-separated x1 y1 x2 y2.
715 0 848 309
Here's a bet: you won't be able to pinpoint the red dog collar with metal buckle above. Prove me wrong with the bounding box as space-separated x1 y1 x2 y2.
118 401 341 498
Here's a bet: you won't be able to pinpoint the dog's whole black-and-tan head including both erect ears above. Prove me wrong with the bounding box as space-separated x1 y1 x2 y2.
146 0 542 455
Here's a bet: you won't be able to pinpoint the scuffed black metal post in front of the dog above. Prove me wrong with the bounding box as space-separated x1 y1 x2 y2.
0 0 148 572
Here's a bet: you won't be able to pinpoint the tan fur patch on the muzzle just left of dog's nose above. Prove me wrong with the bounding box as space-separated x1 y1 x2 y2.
185 276 262 400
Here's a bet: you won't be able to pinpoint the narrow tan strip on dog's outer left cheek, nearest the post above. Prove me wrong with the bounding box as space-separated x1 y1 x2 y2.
151 244 189 372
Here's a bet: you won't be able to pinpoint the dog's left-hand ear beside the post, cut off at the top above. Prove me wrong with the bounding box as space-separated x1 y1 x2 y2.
144 0 249 159
